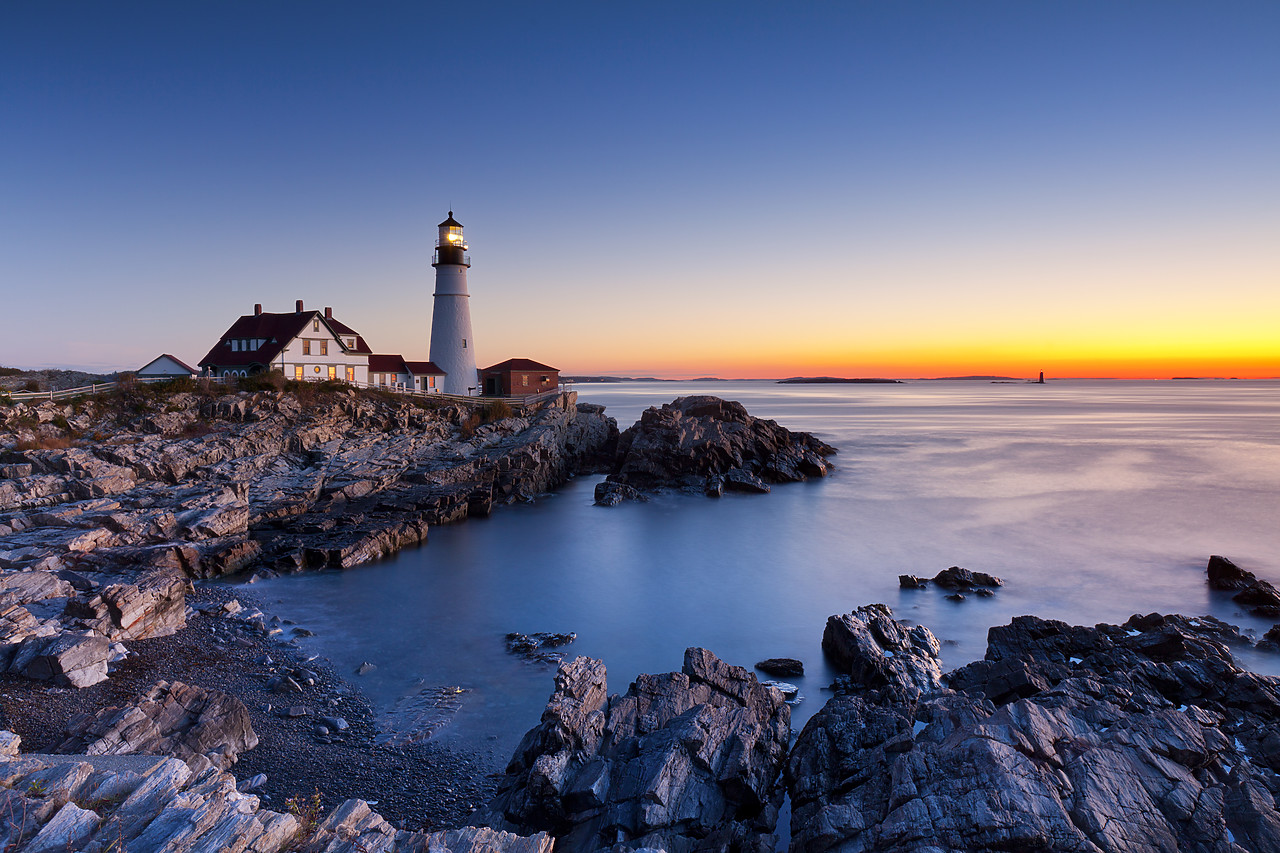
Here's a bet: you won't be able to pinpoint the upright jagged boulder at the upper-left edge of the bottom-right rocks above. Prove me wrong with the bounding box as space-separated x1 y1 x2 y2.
822 596 942 690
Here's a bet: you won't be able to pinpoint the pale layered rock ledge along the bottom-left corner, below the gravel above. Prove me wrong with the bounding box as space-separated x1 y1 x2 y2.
0 731 552 853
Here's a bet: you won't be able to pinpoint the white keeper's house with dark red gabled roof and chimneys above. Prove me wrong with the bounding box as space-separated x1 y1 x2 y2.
200 300 372 384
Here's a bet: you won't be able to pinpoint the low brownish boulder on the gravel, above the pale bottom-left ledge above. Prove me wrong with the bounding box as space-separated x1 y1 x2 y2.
58 681 257 772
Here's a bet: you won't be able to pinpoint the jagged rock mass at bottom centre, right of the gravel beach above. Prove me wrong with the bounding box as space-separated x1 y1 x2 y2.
479 648 791 853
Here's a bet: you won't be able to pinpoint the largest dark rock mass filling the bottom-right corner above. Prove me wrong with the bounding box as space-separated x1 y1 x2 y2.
787 613 1280 853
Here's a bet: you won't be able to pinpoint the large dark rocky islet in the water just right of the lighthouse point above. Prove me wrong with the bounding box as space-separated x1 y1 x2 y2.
596 396 836 506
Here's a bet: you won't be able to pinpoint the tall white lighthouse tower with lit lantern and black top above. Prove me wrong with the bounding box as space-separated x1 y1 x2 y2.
431 210 480 394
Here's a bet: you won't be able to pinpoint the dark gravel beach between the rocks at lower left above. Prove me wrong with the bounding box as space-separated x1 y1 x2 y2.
0 584 500 830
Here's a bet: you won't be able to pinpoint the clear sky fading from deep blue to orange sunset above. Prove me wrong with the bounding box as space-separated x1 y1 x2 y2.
0 0 1280 378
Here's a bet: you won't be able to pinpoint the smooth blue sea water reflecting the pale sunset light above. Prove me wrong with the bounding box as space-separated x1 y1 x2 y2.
241 382 1280 763
